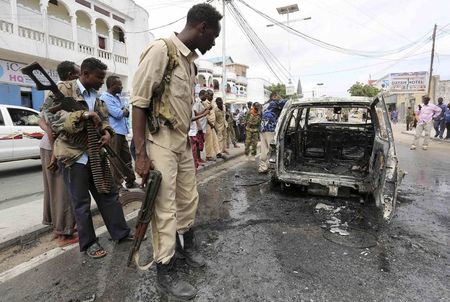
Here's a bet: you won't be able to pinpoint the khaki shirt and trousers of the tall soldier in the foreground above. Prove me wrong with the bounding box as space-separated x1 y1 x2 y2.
131 34 198 264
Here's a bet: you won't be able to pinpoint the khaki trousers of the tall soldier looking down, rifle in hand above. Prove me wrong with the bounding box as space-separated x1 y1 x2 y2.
147 141 198 264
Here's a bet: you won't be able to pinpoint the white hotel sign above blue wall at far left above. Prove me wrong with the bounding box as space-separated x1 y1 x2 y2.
0 60 59 86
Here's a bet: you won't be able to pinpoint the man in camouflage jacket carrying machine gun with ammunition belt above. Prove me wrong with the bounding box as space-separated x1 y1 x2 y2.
44 58 133 258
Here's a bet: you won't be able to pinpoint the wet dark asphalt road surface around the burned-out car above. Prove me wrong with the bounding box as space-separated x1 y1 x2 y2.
0 143 450 301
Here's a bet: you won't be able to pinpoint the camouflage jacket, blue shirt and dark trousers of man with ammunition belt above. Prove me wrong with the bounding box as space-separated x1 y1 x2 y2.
43 80 130 251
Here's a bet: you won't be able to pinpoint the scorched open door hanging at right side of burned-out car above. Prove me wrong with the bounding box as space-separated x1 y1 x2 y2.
371 96 403 222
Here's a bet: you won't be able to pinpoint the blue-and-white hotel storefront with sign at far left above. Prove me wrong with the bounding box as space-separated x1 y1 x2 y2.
0 58 59 110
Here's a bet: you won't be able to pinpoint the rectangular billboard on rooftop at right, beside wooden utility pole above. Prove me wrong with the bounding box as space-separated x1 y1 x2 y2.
389 71 428 93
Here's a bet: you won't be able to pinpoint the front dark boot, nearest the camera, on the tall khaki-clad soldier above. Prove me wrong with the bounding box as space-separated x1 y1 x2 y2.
156 257 197 300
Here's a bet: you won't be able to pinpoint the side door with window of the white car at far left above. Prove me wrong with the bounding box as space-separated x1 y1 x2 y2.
7 107 44 159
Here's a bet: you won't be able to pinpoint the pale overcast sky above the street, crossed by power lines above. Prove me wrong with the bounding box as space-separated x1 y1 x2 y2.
135 0 450 96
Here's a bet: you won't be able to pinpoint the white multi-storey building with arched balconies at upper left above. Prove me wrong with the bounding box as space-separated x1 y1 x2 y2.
0 0 152 109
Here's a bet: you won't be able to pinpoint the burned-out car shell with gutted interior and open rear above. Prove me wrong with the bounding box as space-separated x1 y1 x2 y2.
269 95 403 221
